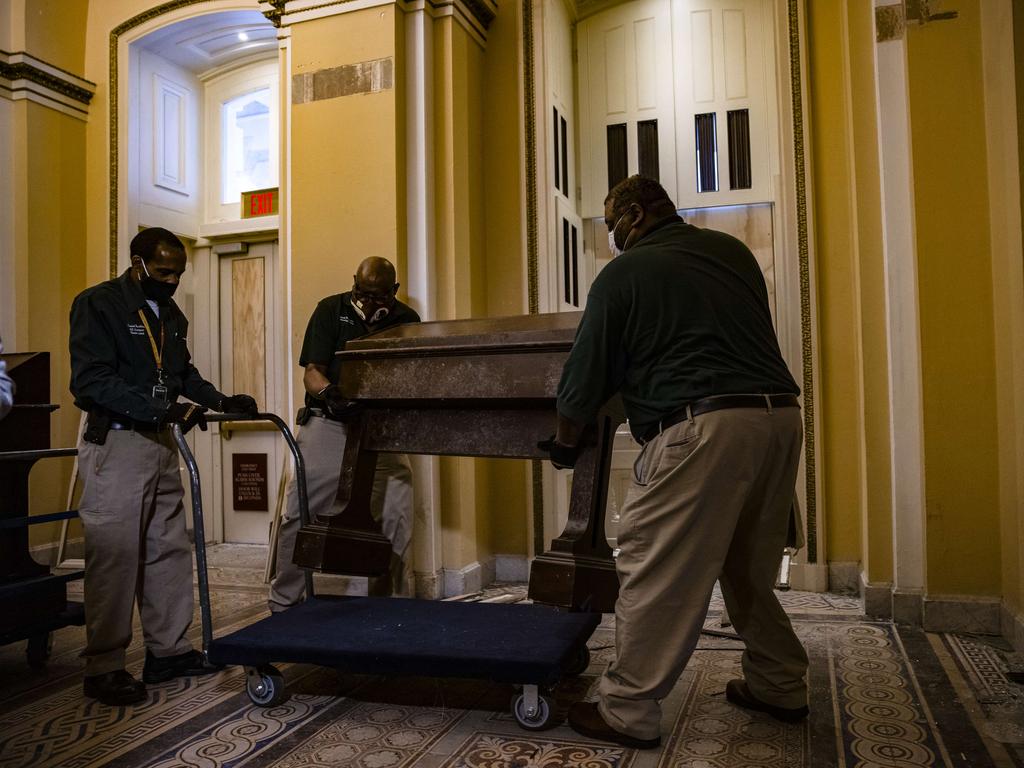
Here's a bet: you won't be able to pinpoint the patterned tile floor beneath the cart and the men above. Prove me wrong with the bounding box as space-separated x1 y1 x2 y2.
0 548 1024 768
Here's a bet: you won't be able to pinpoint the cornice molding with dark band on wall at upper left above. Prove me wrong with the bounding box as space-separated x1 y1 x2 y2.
0 50 96 120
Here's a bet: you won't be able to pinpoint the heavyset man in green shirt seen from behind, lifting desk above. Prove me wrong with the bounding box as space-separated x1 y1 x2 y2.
550 176 808 749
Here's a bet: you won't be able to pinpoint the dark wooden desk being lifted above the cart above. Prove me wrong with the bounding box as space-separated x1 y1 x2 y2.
295 313 623 611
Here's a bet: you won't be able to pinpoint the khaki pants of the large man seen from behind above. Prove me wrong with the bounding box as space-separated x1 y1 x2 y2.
598 408 807 738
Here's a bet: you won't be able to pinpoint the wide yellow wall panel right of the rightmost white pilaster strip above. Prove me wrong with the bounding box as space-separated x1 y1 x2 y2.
906 0 1000 595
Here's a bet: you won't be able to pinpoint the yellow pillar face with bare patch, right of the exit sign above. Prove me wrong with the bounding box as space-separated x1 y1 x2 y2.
291 6 407 415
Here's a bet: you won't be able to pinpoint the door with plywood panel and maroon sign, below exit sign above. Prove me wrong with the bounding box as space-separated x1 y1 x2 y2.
218 243 280 544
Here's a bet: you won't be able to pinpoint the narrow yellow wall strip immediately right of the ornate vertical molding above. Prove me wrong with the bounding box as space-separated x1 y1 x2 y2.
807 3 864 561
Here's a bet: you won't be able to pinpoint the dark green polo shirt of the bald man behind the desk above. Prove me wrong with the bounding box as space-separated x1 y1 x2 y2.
299 291 420 408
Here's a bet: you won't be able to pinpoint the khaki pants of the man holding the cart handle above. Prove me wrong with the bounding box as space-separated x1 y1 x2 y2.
79 430 193 675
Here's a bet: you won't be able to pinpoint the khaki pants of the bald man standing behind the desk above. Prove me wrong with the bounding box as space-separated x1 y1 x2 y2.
269 416 413 610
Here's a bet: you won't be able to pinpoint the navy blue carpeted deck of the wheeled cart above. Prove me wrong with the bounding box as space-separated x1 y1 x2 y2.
209 597 601 684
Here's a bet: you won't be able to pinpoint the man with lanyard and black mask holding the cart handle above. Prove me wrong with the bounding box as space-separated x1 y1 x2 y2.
70 228 256 705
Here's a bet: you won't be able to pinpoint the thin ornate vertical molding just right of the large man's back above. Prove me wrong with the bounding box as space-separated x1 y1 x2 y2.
787 0 818 564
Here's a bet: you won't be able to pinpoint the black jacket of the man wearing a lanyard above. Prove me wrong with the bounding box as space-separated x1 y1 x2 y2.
70 270 224 423
